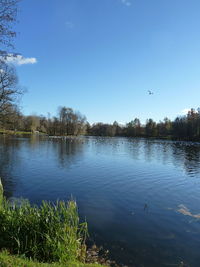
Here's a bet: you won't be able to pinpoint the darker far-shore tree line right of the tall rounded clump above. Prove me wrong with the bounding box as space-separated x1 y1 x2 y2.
87 108 200 141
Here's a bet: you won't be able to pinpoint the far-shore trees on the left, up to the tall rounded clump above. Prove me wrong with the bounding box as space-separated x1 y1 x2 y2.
0 107 87 135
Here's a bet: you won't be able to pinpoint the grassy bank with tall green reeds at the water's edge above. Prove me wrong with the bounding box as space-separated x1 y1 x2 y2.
0 180 106 266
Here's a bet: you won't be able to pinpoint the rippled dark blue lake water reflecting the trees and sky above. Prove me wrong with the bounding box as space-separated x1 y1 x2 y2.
0 136 200 267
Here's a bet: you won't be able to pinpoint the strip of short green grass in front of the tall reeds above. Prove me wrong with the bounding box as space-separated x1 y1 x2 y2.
0 252 106 267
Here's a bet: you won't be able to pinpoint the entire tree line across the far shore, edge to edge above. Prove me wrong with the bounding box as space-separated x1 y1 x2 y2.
0 106 200 141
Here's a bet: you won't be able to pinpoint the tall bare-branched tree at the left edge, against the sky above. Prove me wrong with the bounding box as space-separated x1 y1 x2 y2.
0 0 22 125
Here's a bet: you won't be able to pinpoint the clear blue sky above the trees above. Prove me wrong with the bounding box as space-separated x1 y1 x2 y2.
12 0 200 123
